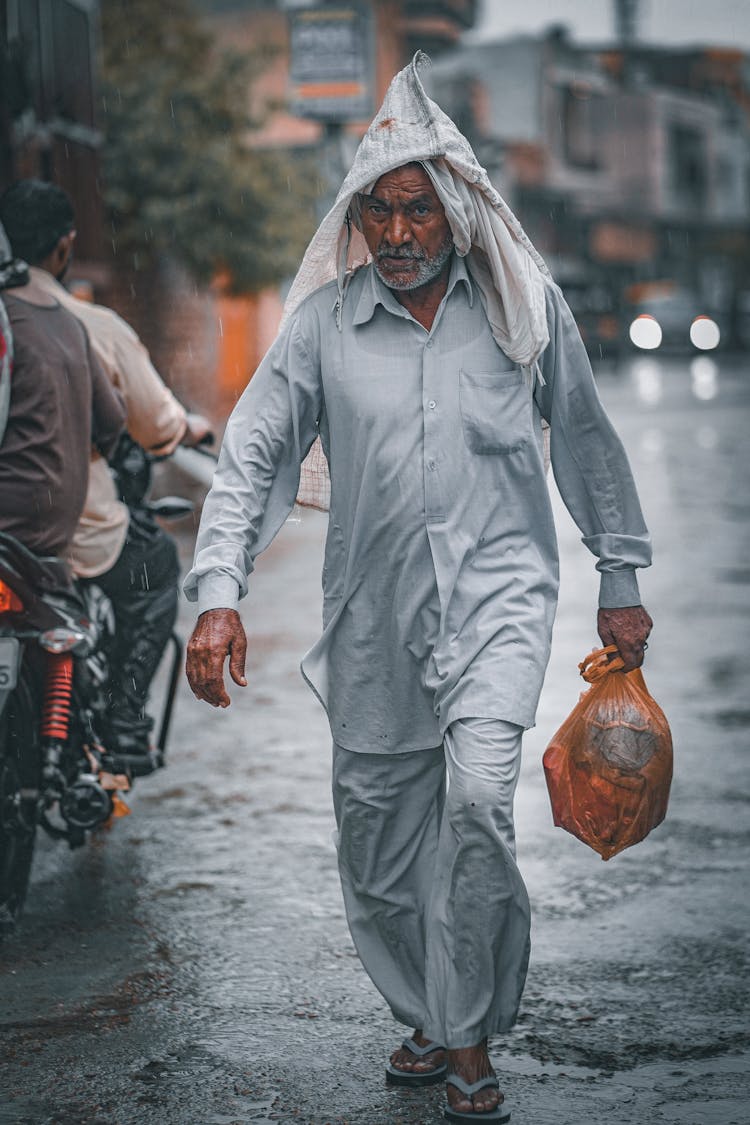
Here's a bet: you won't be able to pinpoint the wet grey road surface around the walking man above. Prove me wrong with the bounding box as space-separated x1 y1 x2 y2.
0 358 750 1125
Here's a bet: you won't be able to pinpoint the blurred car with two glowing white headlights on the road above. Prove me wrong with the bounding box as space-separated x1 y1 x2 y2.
624 281 729 351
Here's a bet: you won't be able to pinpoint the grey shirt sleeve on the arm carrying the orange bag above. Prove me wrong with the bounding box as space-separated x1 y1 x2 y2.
536 286 651 609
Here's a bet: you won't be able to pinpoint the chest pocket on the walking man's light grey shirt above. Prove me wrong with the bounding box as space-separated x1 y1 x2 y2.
459 370 532 453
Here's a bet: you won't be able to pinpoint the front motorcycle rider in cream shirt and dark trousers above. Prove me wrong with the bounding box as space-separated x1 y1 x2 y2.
0 180 210 774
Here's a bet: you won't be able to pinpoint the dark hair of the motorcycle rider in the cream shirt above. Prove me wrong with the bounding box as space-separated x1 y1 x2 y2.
0 180 75 266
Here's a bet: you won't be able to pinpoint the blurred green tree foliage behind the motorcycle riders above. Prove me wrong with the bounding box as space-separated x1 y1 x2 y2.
101 0 314 293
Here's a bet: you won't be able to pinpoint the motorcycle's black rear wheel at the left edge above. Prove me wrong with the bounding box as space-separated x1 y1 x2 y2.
0 671 42 941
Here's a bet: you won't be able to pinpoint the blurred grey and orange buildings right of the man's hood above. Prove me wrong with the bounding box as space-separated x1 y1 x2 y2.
432 28 750 351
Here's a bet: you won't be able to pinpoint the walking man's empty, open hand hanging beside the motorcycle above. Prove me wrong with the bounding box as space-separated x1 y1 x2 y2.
186 610 247 707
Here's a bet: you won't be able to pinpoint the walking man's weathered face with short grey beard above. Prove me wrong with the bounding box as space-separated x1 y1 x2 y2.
362 164 453 289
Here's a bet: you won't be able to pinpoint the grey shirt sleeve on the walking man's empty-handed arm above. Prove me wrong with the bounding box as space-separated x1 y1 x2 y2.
183 315 323 613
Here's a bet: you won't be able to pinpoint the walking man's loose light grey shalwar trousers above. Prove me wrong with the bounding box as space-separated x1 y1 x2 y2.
333 719 530 1049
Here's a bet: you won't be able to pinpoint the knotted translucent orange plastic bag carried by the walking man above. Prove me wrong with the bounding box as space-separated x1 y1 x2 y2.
543 645 672 860
